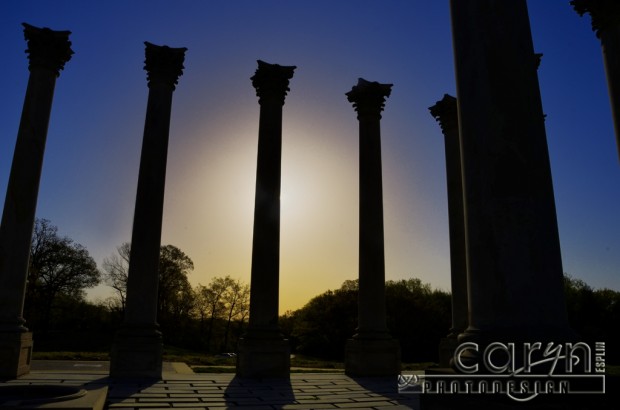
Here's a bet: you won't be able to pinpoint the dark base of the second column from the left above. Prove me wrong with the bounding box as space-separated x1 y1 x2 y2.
110 325 164 379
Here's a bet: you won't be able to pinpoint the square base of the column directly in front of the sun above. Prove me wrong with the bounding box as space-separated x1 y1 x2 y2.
237 337 291 378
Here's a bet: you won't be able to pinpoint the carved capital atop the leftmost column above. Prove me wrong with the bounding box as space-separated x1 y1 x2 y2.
22 23 73 77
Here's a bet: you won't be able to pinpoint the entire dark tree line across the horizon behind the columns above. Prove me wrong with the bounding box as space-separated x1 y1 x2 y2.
24 219 620 364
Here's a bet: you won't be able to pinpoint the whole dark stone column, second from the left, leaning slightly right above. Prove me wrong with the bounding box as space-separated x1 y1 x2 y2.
110 42 187 378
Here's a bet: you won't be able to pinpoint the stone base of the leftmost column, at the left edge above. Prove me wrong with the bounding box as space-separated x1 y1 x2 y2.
0 332 32 380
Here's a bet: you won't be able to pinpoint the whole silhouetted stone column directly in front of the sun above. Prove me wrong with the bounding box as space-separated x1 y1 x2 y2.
237 60 296 377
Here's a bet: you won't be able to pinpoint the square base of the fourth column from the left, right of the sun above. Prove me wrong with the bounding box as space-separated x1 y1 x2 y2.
344 339 400 377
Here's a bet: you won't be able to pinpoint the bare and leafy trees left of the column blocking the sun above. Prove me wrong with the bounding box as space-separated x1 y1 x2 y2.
24 218 250 352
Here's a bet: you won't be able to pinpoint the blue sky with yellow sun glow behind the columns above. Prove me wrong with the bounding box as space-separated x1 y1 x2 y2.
0 0 620 313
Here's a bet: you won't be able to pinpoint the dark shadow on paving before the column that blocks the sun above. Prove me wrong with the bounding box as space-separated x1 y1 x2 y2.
224 375 295 409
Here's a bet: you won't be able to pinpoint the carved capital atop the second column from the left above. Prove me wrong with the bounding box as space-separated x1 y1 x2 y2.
144 41 187 90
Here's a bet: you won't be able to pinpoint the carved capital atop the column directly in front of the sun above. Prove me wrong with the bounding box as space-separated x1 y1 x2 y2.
250 60 297 105
